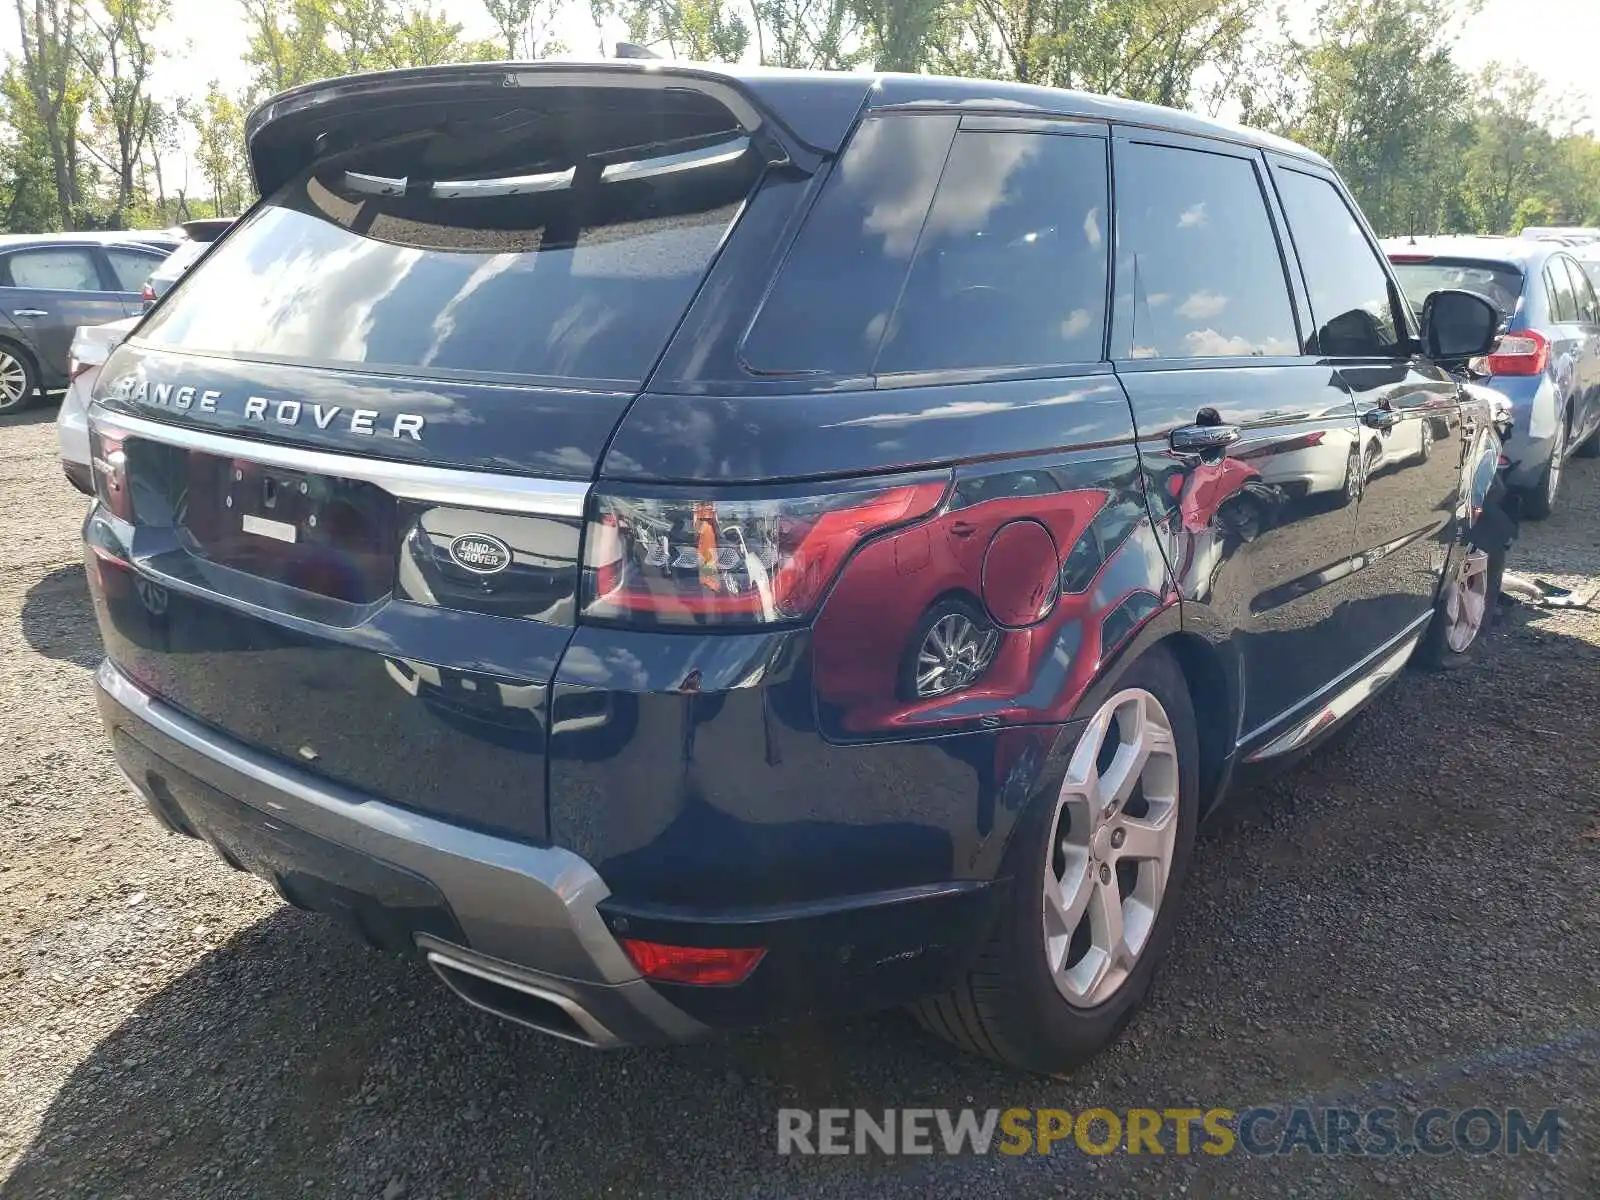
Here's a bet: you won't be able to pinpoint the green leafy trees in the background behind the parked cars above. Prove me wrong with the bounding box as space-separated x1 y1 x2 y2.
0 0 1600 241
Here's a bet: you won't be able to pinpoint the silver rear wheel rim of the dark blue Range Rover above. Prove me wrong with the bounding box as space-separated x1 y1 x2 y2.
1042 688 1179 1008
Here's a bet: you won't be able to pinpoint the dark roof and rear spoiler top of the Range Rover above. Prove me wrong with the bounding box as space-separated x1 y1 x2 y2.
245 59 1325 190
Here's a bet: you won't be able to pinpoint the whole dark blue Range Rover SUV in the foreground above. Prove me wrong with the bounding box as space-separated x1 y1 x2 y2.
85 62 1504 1070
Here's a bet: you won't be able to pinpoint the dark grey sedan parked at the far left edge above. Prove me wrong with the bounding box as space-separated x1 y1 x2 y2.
0 234 176 413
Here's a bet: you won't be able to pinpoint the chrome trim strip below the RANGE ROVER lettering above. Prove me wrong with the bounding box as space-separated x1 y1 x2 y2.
90 406 589 517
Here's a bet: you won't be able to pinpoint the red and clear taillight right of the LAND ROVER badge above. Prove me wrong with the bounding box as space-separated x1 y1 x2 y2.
581 475 947 626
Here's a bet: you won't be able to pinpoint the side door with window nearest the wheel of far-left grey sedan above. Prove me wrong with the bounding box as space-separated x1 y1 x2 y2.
0 243 128 377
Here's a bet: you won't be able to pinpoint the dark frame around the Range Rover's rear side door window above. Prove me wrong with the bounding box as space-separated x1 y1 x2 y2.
1106 125 1310 371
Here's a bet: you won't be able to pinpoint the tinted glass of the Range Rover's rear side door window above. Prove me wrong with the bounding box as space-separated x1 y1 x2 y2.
1114 142 1299 358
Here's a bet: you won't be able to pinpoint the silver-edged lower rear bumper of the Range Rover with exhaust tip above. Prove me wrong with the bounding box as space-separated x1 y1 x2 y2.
96 662 704 1046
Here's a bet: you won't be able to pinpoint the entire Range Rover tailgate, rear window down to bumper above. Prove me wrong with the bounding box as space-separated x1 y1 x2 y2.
90 86 766 840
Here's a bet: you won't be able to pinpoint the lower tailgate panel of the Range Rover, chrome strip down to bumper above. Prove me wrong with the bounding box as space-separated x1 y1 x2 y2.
86 400 584 842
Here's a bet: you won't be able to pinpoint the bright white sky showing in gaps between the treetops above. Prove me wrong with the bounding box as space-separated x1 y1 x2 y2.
0 0 1600 195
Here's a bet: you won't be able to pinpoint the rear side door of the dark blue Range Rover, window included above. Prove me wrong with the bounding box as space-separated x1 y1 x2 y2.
1112 131 1358 739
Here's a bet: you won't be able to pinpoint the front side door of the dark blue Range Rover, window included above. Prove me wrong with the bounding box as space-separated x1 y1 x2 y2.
1274 160 1464 654
